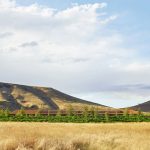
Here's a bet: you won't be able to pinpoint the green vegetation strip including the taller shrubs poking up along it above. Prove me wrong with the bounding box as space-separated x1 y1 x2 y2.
0 109 150 123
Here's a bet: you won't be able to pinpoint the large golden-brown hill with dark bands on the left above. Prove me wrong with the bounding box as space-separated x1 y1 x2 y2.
0 83 111 110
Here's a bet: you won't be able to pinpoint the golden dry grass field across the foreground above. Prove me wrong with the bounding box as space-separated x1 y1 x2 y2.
0 122 150 150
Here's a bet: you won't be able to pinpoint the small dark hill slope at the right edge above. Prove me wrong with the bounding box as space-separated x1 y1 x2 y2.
130 101 150 112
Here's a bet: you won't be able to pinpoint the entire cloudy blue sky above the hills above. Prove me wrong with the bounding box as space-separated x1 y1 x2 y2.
0 0 150 108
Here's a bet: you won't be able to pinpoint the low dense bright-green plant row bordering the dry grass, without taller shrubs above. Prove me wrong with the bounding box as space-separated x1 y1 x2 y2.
0 115 150 123
